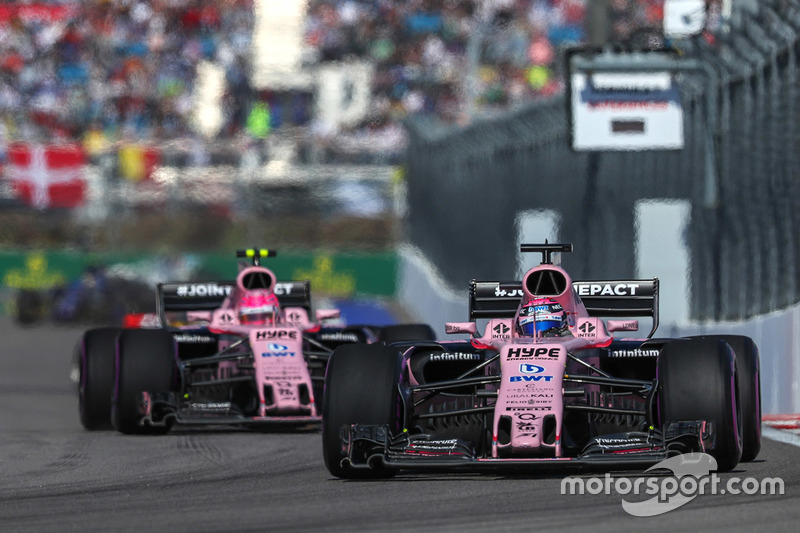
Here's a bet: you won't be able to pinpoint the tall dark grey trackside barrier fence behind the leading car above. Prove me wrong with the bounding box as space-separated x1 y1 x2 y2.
406 0 800 320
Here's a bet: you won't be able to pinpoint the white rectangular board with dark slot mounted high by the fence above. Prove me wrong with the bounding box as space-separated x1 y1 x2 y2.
569 69 683 151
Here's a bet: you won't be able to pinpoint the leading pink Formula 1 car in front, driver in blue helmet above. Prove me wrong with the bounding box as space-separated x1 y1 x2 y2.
322 244 761 478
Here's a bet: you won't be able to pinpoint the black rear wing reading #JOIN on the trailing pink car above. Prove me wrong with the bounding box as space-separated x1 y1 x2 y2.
156 280 311 324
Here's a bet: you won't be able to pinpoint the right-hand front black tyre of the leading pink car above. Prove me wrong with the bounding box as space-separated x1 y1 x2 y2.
658 338 742 472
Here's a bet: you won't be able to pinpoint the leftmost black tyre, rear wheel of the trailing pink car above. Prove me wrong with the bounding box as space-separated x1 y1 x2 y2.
77 328 122 431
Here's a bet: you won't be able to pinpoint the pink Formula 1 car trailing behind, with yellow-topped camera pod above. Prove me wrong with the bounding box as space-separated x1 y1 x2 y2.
77 249 434 433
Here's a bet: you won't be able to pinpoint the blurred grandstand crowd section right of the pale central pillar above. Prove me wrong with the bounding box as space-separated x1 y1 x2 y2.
307 0 663 121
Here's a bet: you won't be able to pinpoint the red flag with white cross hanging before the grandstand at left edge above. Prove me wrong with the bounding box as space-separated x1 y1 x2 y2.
5 143 86 209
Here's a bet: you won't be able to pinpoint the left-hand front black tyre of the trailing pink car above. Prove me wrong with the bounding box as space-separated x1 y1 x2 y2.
111 329 177 434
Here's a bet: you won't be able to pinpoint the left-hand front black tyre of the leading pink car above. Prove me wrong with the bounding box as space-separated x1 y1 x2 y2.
322 344 403 479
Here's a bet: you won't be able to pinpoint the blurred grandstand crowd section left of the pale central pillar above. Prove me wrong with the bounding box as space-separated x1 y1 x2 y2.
0 0 252 156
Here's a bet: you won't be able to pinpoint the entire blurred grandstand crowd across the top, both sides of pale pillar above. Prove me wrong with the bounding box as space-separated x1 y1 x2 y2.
0 0 688 164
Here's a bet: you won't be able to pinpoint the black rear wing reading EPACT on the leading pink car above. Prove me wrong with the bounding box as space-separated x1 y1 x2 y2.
469 278 658 337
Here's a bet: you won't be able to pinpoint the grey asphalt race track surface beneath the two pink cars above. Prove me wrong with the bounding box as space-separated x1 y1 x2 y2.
0 317 800 533
